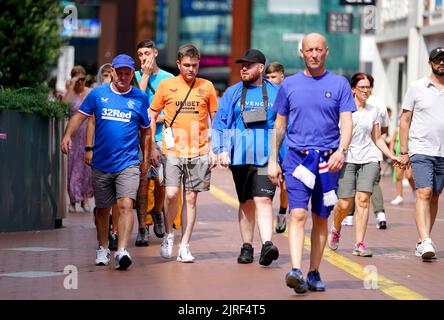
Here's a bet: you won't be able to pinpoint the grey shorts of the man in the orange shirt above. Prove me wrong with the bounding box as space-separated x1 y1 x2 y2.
164 155 211 192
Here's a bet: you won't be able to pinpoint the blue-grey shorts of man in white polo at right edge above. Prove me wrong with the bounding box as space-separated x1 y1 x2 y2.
410 154 444 194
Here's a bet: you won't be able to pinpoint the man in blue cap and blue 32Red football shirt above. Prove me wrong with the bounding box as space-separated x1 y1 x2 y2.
61 54 151 270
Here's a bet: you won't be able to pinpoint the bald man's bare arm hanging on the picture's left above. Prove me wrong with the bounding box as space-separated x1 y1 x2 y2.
268 113 288 185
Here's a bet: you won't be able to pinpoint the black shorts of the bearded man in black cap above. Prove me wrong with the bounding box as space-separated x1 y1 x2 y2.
230 164 276 203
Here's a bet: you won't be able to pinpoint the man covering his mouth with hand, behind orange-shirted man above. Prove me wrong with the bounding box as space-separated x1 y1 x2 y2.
132 40 173 247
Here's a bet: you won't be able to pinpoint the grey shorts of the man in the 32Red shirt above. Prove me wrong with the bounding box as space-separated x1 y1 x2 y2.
92 165 140 208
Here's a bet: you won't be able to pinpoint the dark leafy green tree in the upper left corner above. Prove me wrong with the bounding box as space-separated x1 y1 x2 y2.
0 0 63 88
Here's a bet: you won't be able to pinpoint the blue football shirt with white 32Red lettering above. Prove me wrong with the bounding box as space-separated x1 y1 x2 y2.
79 84 150 173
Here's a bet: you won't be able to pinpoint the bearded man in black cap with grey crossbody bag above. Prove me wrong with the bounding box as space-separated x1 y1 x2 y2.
212 49 279 266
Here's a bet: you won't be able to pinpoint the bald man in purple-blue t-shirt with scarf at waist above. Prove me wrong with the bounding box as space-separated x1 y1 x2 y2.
268 33 356 294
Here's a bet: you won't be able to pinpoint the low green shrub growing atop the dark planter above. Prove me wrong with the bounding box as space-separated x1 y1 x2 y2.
0 87 70 118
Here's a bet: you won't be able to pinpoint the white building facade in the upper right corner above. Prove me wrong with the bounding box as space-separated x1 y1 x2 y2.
372 0 444 119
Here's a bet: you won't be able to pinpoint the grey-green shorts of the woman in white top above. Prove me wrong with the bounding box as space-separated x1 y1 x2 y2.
338 162 379 199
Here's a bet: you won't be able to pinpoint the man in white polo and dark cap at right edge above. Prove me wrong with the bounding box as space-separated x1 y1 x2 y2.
399 47 444 261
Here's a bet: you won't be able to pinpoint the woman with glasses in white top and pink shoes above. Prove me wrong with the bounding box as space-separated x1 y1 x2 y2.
328 73 399 257
